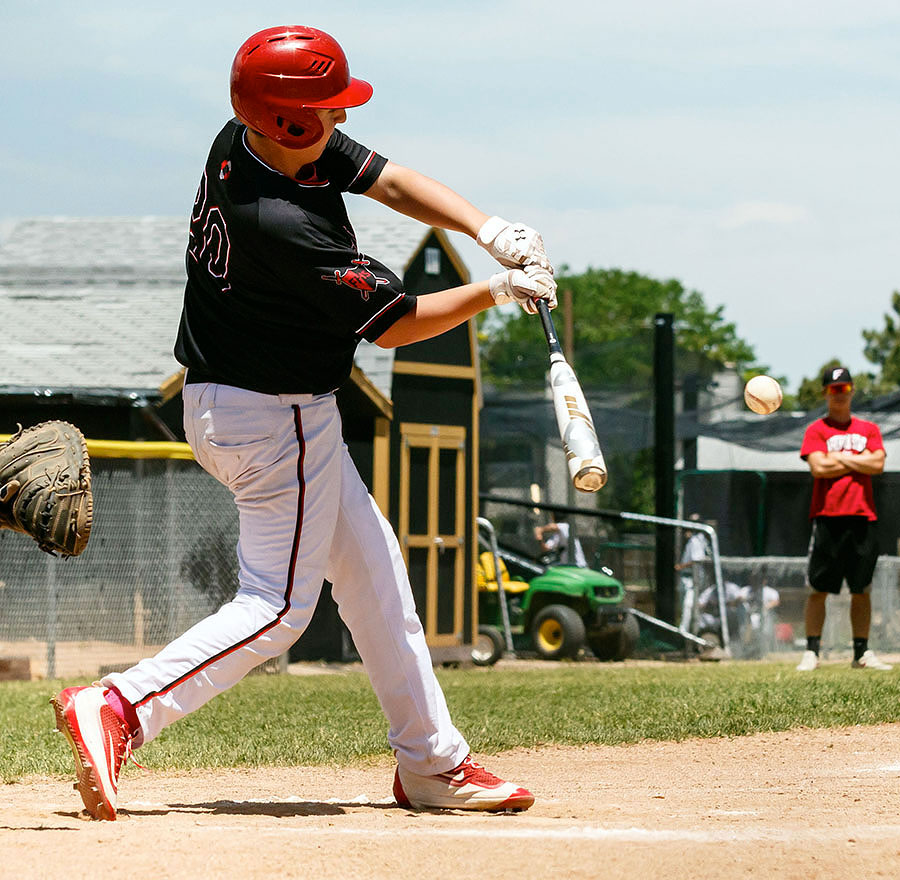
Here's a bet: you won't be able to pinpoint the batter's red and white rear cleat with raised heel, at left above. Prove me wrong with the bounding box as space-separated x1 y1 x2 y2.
50 686 131 820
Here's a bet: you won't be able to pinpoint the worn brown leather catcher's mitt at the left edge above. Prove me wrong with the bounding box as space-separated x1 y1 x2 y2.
0 421 93 556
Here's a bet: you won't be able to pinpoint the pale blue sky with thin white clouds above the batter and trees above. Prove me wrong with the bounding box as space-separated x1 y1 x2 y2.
0 0 900 386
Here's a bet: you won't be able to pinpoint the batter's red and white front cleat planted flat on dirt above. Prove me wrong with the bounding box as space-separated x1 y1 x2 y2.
394 755 534 812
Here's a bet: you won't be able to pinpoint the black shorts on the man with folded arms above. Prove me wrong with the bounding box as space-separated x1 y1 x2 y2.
807 516 878 594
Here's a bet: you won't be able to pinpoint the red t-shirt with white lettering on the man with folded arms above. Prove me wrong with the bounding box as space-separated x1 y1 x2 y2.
800 416 884 521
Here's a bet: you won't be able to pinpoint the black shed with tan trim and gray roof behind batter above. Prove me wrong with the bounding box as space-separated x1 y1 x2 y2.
0 212 480 661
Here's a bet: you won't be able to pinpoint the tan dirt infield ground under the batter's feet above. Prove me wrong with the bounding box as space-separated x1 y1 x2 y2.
0 725 900 880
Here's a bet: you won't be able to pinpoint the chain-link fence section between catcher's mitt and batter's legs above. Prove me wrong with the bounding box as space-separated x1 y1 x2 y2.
0 457 238 678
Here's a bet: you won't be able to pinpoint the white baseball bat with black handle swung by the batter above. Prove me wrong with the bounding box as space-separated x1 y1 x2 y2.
535 299 607 492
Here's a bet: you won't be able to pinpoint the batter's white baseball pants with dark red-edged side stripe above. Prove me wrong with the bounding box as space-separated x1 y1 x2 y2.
103 384 469 775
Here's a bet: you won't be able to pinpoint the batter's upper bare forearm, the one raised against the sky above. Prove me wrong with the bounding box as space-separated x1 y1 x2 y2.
366 162 488 238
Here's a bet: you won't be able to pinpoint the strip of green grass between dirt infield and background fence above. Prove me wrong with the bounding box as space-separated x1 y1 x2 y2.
0 663 900 782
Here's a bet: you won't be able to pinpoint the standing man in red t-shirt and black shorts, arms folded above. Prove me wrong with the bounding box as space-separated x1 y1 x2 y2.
797 367 891 672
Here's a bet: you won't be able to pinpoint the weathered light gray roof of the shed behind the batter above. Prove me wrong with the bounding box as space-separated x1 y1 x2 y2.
0 213 454 396
